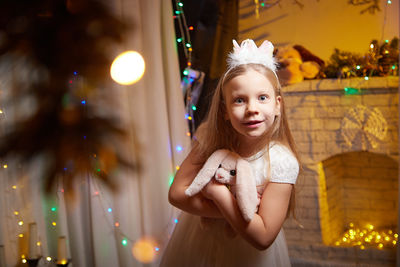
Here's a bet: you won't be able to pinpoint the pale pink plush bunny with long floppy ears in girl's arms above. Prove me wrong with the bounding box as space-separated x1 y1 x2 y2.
185 149 260 222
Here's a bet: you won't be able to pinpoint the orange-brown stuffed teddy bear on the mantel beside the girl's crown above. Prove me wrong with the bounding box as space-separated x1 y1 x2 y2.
276 45 325 85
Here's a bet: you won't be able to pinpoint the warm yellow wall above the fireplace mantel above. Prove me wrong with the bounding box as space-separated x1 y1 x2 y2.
239 0 399 60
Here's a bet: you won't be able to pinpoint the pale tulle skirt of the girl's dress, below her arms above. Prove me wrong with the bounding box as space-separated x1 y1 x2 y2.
160 212 290 267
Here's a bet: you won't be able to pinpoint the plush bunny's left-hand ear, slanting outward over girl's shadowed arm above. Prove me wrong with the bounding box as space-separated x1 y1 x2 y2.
185 149 229 196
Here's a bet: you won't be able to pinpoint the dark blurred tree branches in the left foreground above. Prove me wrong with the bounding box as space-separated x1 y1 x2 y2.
0 0 137 199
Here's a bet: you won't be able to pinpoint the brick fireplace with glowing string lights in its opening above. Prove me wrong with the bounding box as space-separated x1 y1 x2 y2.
283 77 399 266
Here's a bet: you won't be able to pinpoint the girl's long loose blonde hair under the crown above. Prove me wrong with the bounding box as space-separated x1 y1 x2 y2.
196 63 300 218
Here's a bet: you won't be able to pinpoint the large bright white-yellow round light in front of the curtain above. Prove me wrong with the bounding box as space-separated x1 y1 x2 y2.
110 51 145 85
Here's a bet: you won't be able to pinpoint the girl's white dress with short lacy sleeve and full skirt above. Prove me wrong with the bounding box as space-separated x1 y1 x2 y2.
160 143 299 267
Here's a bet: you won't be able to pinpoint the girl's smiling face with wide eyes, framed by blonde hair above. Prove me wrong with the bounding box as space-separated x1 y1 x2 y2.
224 70 281 143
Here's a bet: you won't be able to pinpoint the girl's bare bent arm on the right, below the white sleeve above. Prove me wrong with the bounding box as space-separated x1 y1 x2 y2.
203 182 293 250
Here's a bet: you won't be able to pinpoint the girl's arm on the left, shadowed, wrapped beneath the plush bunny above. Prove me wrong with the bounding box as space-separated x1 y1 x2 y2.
168 145 223 218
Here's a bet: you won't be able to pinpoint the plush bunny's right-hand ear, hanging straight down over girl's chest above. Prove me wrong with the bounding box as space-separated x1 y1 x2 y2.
236 159 259 222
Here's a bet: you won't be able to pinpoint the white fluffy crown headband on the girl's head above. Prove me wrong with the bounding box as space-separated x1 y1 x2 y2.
227 39 277 72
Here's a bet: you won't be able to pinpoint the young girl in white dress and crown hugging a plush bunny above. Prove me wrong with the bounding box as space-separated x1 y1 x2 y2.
161 40 299 267
